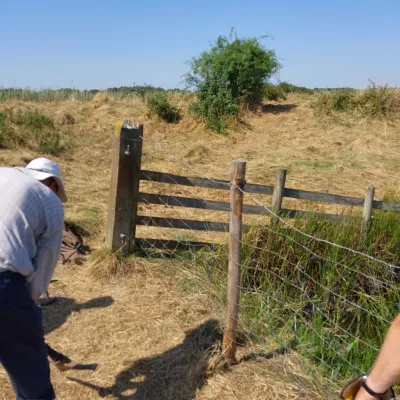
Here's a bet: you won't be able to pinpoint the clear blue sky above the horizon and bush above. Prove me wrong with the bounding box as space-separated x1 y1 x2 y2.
0 0 400 89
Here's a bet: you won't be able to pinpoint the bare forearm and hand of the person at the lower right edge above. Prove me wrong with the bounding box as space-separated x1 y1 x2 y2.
355 315 400 400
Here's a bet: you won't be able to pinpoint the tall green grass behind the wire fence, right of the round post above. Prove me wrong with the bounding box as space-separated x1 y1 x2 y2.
177 212 400 382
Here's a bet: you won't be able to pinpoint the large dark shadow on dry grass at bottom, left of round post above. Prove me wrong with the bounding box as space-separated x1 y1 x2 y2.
69 319 222 400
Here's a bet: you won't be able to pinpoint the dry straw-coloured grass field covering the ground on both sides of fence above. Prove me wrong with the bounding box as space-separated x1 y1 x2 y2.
0 93 400 400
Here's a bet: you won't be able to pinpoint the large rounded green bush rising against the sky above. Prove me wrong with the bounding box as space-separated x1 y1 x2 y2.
186 32 280 133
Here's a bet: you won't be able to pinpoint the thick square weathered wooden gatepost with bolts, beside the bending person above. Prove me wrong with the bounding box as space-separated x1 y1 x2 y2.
105 121 143 254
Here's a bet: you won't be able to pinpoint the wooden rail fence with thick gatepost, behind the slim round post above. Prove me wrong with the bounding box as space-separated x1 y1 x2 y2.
106 121 400 252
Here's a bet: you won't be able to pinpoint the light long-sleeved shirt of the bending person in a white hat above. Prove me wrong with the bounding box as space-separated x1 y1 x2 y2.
0 168 64 298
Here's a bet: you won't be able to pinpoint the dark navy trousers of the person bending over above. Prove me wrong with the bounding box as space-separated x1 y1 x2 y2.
0 271 55 400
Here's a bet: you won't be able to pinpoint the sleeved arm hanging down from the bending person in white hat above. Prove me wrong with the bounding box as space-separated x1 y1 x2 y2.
28 213 64 299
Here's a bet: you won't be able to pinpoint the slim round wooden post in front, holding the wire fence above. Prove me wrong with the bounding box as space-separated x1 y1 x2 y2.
224 160 246 363
